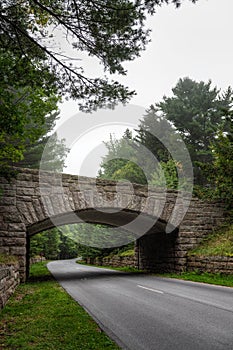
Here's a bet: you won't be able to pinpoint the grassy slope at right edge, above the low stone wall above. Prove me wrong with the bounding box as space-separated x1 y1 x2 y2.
190 225 233 256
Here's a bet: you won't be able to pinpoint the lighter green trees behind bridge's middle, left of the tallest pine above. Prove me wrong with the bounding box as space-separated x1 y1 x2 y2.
100 106 191 189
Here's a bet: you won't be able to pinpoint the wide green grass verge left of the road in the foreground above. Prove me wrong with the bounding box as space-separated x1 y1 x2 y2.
0 262 119 350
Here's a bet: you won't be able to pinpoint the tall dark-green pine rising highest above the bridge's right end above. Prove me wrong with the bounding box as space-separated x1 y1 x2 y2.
156 78 233 185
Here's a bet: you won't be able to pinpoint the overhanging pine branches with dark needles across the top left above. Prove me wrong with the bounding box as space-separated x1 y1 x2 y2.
0 0 195 110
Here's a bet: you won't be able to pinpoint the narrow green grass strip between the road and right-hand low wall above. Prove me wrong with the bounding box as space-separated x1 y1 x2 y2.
156 272 233 287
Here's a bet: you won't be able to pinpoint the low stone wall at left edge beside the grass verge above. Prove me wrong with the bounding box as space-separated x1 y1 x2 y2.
0 264 20 309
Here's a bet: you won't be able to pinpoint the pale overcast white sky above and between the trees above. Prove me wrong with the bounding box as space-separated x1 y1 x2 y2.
53 0 233 175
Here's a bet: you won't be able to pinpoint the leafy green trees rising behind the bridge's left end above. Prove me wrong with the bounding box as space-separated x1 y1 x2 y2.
0 49 67 177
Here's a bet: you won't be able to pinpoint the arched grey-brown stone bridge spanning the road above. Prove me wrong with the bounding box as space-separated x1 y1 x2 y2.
0 169 227 280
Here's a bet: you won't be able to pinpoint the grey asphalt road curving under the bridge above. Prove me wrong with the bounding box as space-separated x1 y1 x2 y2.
48 260 233 350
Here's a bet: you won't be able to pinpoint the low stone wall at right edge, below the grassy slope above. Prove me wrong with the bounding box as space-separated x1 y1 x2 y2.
187 256 233 275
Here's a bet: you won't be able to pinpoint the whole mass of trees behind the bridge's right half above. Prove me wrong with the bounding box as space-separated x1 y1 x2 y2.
100 78 233 193
